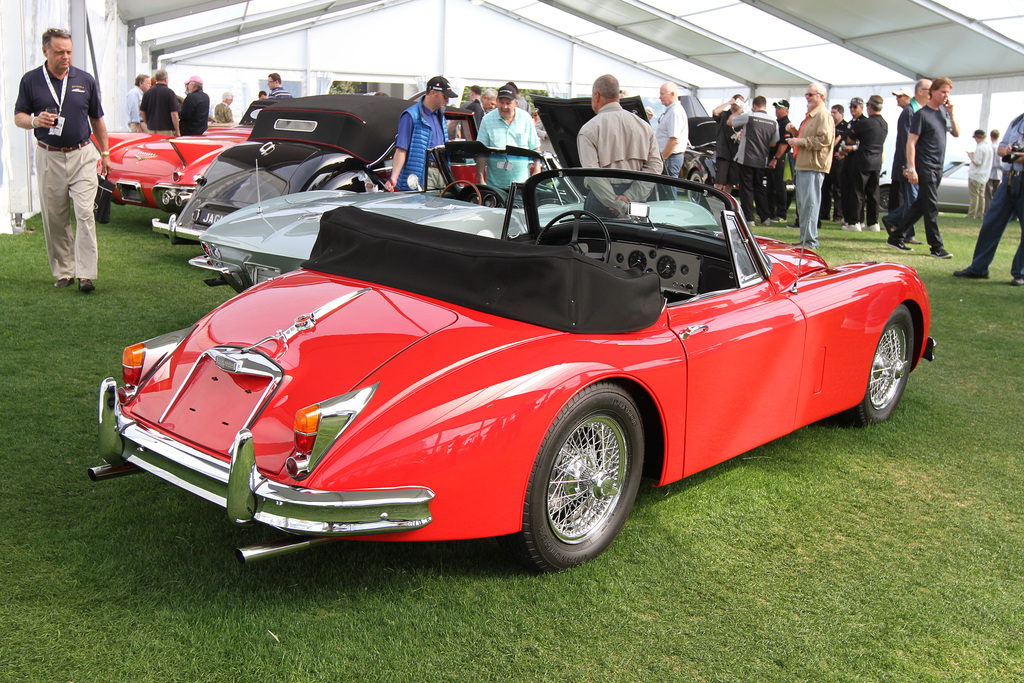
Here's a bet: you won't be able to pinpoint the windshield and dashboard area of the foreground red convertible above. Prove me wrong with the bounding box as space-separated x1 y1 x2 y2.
504 169 770 302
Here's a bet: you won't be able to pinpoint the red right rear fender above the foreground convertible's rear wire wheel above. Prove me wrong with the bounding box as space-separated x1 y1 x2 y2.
302 314 685 541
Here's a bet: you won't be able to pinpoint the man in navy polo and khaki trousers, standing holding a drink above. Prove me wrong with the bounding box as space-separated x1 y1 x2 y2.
14 29 111 293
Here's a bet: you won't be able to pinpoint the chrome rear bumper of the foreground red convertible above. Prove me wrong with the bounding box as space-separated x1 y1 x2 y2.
90 378 434 537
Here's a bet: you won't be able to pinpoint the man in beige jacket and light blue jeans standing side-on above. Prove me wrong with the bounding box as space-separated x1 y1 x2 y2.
790 83 836 249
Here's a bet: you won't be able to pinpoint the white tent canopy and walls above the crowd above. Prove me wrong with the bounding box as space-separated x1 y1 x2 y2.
0 0 1024 231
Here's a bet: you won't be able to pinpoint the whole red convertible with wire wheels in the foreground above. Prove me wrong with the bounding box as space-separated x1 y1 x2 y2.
90 169 934 571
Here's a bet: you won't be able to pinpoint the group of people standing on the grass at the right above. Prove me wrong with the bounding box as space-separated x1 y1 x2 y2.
712 78 1024 286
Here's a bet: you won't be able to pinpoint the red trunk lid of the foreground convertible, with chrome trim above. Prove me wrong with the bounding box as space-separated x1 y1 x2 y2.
131 270 459 472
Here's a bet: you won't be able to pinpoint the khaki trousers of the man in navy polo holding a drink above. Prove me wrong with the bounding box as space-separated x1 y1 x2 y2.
36 144 99 280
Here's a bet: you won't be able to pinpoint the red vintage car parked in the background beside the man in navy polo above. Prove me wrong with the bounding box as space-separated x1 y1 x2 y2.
106 99 276 213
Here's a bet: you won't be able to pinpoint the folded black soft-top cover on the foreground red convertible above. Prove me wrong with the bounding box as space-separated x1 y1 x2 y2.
302 207 664 334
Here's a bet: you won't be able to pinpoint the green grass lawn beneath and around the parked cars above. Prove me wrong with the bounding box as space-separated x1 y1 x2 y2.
0 202 1024 683
